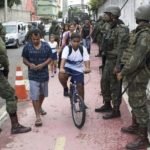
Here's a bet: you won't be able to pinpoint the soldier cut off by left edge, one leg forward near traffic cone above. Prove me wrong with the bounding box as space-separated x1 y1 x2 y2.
0 37 31 134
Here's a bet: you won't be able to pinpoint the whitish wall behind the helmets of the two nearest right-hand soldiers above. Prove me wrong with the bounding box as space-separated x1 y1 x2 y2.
98 0 150 30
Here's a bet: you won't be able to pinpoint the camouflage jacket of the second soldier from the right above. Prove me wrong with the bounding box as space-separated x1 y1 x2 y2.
104 21 129 67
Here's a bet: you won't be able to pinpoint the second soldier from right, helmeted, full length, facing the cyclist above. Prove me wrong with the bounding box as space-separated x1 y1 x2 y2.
95 6 129 119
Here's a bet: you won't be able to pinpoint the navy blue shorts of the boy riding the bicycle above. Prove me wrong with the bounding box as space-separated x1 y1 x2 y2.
65 67 84 84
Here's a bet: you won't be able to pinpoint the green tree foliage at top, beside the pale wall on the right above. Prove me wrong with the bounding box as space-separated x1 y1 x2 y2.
89 0 106 17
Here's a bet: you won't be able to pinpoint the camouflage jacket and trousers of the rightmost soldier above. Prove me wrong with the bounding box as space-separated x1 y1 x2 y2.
121 25 150 127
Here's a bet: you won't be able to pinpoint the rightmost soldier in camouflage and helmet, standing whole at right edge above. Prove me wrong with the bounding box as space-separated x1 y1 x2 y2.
117 5 150 150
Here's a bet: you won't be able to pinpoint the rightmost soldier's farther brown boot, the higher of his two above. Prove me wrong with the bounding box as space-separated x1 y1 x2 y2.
121 115 139 134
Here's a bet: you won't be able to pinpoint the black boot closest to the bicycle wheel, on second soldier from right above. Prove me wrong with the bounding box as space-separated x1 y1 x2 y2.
95 102 112 113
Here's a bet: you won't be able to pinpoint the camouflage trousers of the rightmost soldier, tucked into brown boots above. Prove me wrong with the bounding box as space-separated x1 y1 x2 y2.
128 77 149 127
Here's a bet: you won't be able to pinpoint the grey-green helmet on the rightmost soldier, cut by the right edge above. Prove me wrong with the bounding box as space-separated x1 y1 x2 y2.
135 5 150 21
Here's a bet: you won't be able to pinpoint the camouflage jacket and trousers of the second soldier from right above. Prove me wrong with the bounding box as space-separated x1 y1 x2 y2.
102 24 129 110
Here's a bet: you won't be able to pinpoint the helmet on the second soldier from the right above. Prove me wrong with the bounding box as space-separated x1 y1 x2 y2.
104 6 121 17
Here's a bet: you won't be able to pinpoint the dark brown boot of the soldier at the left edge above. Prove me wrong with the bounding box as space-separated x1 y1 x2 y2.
9 113 31 134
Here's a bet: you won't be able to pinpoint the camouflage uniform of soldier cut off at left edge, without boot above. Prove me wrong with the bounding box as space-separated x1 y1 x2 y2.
0 38 17 113
